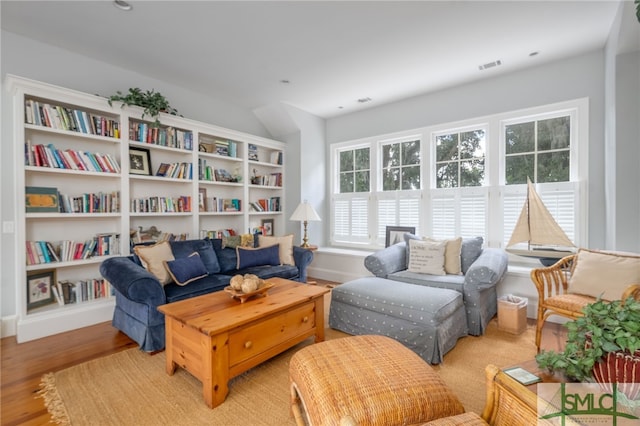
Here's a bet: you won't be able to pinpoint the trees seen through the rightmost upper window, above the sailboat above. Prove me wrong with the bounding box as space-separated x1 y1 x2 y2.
505 116 571 185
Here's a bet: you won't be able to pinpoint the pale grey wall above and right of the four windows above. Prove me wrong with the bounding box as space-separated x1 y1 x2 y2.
327 50 605 247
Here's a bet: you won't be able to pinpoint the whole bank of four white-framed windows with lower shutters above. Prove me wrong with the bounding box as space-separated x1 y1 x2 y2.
331 99 588 253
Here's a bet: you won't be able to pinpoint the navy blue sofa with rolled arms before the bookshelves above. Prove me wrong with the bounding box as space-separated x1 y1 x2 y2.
100 238 313 352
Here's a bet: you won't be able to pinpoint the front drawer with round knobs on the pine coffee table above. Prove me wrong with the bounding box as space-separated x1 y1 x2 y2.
229 302 315 365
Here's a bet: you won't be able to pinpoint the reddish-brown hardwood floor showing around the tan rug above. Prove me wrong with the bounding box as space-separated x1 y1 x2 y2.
0 279 566 426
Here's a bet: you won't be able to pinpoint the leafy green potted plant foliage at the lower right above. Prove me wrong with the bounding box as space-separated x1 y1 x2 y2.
536 297 640 381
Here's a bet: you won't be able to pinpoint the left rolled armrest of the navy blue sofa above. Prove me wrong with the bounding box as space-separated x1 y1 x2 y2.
100 256 167 306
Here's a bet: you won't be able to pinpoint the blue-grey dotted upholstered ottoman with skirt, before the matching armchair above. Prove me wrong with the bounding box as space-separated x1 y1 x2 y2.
329 277 468 364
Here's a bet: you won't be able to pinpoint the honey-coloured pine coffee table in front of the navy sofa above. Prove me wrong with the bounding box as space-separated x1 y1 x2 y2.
158 278 330 408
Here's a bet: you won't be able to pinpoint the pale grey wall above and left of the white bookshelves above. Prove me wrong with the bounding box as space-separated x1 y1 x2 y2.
0 31 272 322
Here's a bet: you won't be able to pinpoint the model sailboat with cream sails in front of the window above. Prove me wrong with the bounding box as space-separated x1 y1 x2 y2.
506 178 575 264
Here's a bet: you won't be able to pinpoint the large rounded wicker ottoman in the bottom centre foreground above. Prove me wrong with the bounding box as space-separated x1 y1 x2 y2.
289 336 464 426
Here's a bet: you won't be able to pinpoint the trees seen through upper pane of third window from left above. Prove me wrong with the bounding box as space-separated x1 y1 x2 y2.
435 129 486 188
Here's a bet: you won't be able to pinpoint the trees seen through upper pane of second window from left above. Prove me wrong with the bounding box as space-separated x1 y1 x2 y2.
381 140 420 191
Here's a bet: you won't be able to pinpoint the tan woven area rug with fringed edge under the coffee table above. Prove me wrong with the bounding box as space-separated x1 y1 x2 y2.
40 320 535 426
